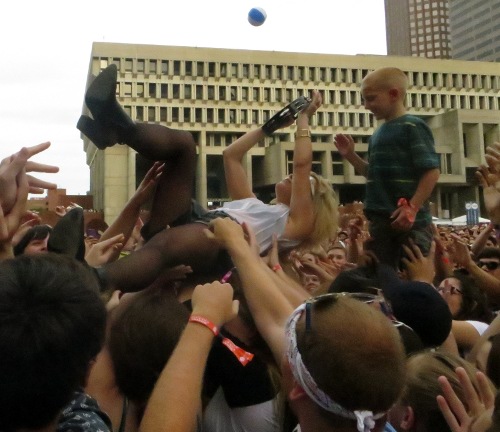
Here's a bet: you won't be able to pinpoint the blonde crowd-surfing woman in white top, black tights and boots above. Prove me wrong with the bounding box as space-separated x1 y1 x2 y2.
77 65 338 291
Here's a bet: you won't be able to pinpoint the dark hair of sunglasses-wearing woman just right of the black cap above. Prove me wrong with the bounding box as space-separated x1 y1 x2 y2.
452 272 493 324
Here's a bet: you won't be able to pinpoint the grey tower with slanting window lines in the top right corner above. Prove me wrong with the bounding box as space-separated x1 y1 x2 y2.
450 0 500 62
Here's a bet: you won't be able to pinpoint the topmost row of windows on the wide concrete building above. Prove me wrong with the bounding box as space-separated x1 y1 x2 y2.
100 58 500 90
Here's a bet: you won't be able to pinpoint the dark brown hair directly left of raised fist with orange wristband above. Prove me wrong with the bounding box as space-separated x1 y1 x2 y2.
107 287 189 404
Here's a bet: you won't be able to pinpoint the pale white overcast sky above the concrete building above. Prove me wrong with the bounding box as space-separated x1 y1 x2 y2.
0 0 387 195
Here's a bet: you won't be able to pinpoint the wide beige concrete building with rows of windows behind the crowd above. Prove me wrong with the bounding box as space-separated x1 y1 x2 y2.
82 43 500 223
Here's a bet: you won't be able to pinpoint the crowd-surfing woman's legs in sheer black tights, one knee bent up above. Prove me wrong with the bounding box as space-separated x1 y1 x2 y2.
104 123 227 291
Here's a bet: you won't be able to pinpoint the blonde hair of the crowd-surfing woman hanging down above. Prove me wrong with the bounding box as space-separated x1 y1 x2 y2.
304 172 339 245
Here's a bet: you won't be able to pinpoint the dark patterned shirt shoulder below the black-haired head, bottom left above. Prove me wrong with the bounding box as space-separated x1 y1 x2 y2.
57 391 112 432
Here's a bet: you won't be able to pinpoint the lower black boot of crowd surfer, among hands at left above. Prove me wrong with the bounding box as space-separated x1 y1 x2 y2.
47 207 85 261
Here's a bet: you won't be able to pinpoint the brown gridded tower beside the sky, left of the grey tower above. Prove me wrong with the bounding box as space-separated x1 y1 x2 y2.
385 0 452 59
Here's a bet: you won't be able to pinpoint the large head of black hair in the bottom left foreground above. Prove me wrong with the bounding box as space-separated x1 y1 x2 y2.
0 253 106 430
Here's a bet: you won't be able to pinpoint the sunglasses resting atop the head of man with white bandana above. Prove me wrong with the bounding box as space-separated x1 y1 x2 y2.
305 288 396 332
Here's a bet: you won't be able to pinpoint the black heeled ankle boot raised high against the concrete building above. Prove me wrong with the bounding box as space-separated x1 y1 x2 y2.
82 64 135 148
